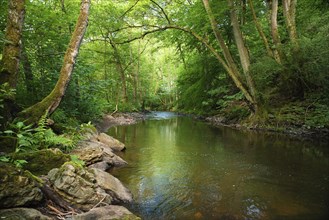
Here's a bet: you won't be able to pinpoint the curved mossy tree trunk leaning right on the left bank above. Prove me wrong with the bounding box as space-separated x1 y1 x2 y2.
19 0 90 123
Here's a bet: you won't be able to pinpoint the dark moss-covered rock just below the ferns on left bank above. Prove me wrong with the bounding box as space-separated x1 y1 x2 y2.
13 148 71 175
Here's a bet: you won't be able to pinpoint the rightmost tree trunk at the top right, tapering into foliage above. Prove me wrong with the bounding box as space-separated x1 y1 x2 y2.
282 0 298 48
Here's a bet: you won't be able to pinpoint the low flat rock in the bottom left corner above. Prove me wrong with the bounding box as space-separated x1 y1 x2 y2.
0 208 51 220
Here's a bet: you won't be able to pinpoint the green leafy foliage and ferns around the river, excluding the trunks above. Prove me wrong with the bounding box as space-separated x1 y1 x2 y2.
0 0 329 131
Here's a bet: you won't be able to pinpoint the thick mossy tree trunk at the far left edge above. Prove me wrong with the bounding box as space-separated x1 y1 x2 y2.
0 0 25 127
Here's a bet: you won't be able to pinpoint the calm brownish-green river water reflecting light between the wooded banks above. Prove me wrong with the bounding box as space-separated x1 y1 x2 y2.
108 112 329 220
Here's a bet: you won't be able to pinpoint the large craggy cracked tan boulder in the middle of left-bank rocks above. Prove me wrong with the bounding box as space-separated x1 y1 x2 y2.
48 162 112 211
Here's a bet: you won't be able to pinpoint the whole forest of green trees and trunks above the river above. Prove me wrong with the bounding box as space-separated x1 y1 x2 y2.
0 0 329 130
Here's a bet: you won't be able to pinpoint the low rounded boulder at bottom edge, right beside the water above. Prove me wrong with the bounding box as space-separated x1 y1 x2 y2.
72 205 141 220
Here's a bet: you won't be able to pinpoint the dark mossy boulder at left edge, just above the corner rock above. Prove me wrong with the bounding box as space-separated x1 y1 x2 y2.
0 163 43 208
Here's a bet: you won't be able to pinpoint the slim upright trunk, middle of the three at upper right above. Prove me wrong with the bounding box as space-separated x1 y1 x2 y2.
270 0 282 63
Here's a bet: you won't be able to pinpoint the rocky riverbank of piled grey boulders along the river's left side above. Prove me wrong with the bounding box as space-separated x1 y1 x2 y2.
0 115 140 220
